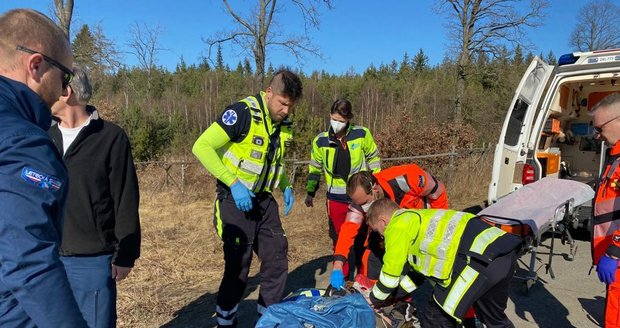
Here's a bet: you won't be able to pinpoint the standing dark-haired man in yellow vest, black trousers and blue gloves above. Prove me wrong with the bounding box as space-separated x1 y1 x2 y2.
192 70 302 327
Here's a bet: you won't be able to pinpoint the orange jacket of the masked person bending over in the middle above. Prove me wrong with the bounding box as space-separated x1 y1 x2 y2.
334 164 448 262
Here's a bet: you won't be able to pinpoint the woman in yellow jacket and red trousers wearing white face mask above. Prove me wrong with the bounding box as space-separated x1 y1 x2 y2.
305 99 381 278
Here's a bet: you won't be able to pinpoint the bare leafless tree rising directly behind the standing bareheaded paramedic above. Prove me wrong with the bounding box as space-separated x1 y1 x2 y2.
204 0 332 82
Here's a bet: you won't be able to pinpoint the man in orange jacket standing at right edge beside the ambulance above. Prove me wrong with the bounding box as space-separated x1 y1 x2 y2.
592 93 620 327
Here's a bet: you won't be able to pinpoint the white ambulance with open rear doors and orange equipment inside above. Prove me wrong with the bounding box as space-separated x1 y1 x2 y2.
487 49 620 228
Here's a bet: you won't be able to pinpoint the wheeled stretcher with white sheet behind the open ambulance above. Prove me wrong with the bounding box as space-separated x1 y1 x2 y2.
478 178 594 294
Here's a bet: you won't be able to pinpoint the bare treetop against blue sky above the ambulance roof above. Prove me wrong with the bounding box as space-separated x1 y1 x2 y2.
569 0 620 51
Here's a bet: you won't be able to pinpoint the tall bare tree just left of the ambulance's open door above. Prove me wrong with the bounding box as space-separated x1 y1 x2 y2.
438 0 547 122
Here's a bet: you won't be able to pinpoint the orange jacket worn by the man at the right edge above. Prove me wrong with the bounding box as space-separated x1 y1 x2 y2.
592 142 620 264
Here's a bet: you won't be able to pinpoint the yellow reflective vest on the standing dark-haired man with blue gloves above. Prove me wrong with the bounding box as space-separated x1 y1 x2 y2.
218 92 293 193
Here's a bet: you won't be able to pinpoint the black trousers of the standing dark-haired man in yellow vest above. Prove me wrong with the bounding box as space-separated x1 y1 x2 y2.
214 189 288 326
